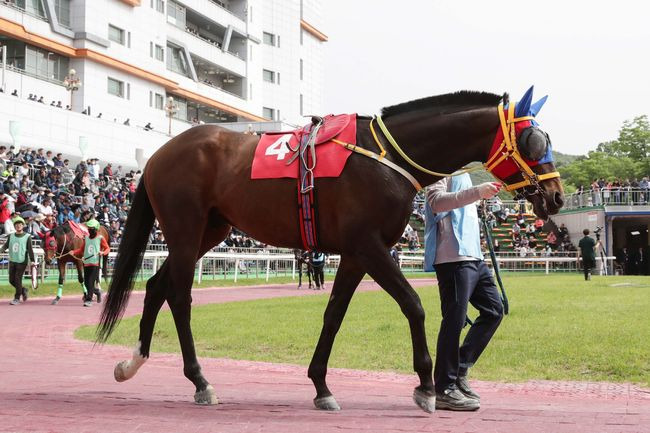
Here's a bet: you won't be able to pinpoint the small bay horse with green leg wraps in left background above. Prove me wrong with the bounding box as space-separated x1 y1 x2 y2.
40 222 111 305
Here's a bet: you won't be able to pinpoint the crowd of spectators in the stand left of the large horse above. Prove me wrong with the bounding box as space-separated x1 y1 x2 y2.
0 146 142 242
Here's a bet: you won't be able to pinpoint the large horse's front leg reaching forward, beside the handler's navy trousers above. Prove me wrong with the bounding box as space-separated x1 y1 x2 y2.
359 244 436 413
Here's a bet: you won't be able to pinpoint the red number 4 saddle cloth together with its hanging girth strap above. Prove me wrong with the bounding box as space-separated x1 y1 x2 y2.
251 114 357 251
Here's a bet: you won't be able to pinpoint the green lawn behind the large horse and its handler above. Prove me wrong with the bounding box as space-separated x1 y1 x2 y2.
76 274 650 386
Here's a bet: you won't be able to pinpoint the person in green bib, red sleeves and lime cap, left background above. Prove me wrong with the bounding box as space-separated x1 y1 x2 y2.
70 219 111 307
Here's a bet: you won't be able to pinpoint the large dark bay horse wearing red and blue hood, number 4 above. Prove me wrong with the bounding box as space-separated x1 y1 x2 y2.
97 89 563 413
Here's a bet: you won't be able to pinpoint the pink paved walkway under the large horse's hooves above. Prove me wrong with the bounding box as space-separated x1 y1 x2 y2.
0 281 650 433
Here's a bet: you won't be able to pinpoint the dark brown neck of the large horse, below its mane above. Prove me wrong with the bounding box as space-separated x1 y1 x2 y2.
384 107 499 186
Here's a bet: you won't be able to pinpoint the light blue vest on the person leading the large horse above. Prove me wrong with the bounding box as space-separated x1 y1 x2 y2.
424 173 483 272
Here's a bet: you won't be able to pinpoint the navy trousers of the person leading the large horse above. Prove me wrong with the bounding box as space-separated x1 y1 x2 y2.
433 260 503 393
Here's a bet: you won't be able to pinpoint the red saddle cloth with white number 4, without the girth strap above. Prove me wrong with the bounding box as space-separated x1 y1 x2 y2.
251 114 357 179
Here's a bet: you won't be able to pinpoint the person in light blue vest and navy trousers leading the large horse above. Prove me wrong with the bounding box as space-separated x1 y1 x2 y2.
425 174 503 411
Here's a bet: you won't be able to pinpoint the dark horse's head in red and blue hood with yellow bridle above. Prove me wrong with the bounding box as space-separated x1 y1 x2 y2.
484 87 564 219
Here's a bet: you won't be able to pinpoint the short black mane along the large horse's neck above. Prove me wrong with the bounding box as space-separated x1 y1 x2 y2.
381 90 508 118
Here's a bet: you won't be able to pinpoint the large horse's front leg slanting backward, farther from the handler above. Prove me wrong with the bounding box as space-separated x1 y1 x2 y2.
307 257 365 410
